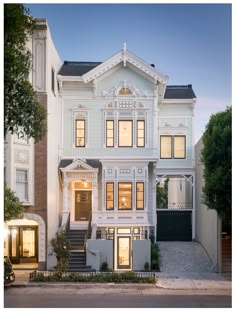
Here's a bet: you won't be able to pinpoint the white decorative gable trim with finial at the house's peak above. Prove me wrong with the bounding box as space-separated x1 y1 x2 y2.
82 49 168 84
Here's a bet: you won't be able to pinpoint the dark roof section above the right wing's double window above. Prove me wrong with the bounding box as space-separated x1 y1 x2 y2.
164 85 196 99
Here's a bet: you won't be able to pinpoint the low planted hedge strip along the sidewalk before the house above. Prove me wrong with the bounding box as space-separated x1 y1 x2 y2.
32 272 156 284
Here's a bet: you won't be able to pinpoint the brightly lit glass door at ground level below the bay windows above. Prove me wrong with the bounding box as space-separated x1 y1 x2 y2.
117 237 131 269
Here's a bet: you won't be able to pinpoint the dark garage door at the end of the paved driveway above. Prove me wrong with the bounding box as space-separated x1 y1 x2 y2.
157 210 192 241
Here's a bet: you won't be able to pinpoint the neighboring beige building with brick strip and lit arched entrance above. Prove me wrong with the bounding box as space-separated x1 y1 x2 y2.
4 19 62 269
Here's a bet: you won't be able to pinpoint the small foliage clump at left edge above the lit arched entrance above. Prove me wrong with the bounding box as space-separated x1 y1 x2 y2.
4 184 24 222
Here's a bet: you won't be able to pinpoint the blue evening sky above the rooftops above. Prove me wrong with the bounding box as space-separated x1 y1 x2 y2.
27 3 232 141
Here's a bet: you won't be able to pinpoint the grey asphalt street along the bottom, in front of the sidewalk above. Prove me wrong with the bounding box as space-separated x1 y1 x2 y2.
4 287 231 308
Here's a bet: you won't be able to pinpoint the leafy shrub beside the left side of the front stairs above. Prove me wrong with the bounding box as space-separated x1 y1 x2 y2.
50 230 70 277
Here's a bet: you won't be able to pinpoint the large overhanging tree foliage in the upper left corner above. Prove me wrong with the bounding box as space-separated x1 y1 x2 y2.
4 4 46 142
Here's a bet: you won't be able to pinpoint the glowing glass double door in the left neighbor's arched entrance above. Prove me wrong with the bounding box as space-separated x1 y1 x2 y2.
9 226 38 264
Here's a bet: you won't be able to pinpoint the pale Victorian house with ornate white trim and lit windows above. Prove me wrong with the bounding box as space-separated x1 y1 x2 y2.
57 45 195 270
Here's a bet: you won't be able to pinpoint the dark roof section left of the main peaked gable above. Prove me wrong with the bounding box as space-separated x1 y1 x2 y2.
58 61 102 76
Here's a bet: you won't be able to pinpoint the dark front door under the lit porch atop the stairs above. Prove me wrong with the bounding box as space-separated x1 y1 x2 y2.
75 190 92 221
